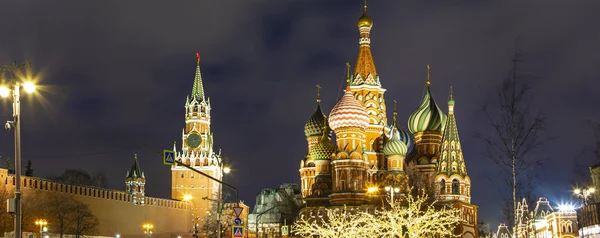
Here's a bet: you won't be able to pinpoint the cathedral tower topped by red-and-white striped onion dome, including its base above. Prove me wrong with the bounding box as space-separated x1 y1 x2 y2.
329 63 369 205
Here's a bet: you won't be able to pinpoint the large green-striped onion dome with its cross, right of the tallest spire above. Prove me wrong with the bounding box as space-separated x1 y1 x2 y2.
408 65 447 134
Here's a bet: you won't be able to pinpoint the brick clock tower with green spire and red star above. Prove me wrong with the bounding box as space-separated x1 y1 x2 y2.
171 53 223 214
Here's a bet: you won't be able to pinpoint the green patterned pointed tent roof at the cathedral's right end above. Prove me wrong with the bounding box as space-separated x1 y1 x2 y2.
438 87 467 178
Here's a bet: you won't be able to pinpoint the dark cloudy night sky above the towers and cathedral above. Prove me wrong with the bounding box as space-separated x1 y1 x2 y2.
0 0 600 230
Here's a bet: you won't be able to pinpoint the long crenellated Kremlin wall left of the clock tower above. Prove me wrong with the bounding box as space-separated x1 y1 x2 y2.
0 169 193 238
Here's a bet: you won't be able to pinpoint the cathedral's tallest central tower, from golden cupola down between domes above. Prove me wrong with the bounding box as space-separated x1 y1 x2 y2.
350 1 389 175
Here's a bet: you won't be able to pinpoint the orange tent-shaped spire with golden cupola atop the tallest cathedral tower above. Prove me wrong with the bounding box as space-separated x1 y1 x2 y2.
352 0 381 87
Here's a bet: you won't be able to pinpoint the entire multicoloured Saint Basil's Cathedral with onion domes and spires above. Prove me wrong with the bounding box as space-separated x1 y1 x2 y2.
300 4 478 237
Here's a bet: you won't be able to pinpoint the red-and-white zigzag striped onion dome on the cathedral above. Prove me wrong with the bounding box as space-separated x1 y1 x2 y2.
329 86 369 131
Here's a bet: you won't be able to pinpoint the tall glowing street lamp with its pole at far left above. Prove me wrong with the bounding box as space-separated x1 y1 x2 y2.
0 62 35 238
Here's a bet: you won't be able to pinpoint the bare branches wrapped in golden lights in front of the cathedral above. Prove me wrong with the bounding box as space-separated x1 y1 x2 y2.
292 194 461 238
